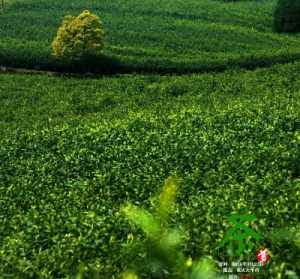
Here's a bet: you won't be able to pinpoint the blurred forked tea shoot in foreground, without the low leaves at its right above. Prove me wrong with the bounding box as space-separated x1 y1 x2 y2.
122 178 185 278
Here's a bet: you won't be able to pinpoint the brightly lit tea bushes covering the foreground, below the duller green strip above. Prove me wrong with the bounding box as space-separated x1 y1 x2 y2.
0 102 300 278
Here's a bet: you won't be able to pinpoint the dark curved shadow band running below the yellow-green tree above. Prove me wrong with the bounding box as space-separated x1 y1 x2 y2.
0 52 300 78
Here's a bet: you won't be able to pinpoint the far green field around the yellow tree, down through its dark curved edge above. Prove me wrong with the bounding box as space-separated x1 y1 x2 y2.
0 0 300 73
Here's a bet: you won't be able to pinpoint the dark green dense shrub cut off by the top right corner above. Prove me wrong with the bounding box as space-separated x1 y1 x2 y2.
274 0 300 32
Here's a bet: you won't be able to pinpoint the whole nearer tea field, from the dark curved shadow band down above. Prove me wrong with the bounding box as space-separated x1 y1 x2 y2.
0 63 300 278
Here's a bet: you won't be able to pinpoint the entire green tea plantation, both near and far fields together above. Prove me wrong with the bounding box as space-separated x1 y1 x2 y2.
0 0 300 279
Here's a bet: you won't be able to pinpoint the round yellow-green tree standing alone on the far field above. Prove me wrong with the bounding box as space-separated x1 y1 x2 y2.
52 10 104 62
